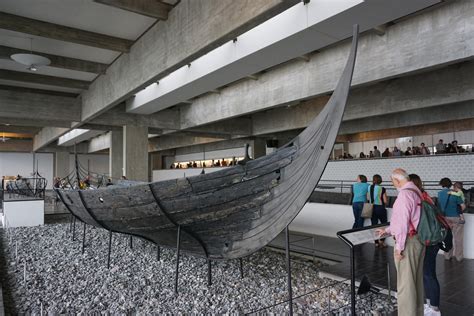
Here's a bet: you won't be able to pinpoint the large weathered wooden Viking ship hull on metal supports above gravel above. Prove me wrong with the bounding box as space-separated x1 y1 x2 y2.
57 26 358 260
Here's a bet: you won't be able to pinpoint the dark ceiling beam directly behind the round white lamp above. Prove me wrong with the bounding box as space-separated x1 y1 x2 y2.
0 45 108 74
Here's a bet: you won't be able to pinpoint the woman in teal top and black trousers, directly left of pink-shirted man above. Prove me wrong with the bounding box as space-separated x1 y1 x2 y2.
367 174 388 248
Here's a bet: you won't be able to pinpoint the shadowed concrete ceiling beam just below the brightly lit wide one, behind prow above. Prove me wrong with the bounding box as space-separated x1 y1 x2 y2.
252 62 474 135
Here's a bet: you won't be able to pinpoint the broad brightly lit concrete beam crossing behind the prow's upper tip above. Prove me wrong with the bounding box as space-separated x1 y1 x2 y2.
180 1 474 132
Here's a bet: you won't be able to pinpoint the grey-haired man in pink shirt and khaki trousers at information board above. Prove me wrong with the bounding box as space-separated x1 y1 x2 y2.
377 169 425 316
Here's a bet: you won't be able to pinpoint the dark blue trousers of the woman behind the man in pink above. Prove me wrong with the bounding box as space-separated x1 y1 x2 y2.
423 245 439 307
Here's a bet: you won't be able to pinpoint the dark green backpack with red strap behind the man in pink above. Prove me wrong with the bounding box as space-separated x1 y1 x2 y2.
407 189 452 247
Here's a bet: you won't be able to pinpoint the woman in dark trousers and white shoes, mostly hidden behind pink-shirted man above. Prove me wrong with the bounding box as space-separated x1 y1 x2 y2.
408 174 441 315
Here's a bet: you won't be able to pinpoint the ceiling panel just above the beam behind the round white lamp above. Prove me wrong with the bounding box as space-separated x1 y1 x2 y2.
0 29 120 64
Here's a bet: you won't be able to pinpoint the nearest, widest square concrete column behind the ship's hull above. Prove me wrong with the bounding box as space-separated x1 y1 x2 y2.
123 125 148 181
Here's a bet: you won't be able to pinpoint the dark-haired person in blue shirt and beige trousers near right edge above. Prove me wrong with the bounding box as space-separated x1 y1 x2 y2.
438 178 466 261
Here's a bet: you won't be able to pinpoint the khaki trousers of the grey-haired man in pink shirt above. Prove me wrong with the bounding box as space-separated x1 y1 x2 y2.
394 236 425 316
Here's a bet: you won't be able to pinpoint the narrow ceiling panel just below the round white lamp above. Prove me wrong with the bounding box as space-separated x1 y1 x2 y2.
0 59 97 81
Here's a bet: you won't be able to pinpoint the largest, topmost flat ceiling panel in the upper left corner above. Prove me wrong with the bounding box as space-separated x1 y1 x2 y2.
0 0 155 40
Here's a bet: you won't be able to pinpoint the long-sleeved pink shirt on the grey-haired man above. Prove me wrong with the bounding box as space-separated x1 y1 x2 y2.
385 182 421 251
